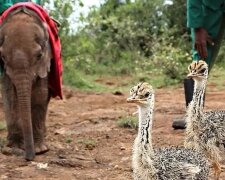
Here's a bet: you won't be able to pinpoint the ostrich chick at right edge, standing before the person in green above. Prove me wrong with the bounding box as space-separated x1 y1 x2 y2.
185 61 225 179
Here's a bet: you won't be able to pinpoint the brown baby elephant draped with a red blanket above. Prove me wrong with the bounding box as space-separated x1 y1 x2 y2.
0 7 58 160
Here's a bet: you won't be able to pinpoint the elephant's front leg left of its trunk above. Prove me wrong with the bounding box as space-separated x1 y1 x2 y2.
1 73 23 148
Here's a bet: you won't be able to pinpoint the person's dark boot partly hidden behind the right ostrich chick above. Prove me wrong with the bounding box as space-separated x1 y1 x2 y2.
172 79 194 129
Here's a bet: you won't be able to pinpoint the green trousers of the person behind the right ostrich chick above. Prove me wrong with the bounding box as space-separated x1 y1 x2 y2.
191 12 225 71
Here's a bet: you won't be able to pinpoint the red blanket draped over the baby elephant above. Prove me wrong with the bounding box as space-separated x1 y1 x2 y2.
0 2 63 99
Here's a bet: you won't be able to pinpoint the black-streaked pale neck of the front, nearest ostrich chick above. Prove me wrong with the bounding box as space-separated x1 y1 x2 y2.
132 94 158 179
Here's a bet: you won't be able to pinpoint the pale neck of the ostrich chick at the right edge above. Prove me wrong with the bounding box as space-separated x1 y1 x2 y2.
187 80 206 129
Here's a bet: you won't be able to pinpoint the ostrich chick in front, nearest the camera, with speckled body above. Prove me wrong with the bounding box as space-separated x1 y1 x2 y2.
127 83 209 180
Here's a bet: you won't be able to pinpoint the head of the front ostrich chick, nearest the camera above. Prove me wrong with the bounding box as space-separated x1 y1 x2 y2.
127 82 154 106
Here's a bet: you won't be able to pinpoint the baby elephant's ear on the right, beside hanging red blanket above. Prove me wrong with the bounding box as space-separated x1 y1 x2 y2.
36 23 53 78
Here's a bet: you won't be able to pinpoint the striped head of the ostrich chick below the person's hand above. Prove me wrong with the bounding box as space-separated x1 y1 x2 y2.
187 60 208 80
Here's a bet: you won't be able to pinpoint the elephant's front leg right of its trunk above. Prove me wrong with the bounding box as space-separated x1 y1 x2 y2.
31 78 50 154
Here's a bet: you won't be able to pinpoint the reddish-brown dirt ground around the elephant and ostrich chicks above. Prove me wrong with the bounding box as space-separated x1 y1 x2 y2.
0 81 225 180
